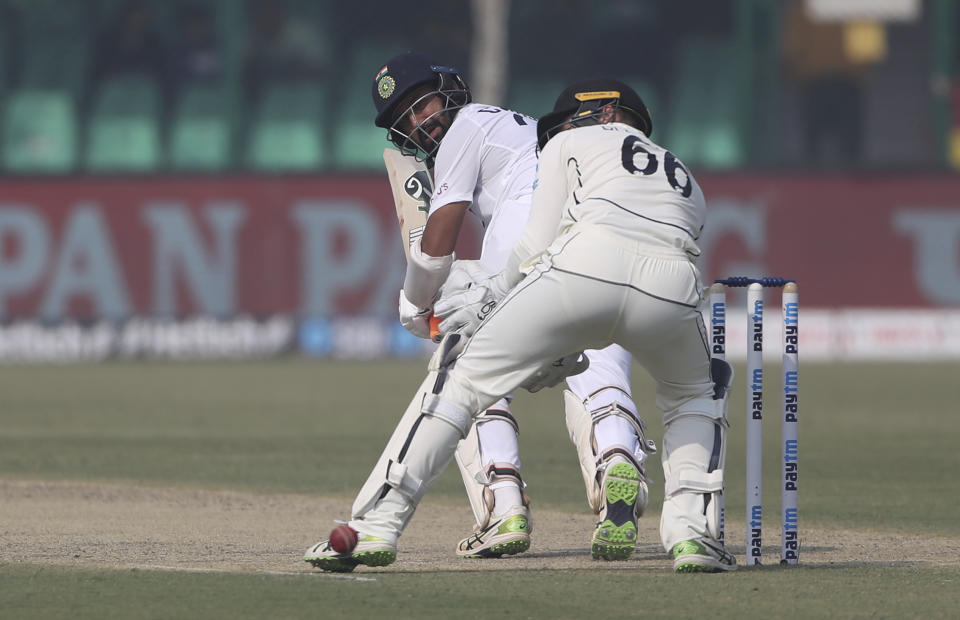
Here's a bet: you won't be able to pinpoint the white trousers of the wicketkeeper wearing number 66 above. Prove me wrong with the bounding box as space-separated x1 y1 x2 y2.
440 227 717 549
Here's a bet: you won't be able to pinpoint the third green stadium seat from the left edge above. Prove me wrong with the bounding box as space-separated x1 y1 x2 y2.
168 84 233 172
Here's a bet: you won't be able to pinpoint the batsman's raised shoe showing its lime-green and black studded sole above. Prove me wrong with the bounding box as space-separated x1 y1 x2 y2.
590 463 647 560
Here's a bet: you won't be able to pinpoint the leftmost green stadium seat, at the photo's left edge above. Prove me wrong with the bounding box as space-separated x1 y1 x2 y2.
3 90 77 173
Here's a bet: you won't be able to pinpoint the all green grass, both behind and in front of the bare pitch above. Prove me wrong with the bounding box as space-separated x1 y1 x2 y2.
0 359 960 619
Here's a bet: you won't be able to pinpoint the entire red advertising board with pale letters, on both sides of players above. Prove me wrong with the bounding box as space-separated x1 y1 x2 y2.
0 174 960 321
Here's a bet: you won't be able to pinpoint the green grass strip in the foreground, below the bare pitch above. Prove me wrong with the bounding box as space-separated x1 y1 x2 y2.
0 567 960 620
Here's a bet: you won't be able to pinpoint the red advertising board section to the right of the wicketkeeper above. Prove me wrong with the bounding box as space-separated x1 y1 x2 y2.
700 175 960 307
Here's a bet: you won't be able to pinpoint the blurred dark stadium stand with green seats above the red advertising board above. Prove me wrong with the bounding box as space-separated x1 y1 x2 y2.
0 0 960 175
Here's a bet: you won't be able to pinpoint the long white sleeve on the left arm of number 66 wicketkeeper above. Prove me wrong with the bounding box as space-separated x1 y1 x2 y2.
508 138 569 278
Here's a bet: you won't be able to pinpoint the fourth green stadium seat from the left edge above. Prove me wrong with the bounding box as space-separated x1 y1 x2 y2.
247 82 329 172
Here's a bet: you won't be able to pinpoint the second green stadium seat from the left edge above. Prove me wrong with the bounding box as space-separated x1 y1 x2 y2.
85 77 161 172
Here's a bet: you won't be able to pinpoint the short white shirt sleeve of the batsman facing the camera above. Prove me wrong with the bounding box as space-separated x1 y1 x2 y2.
427 118 484 217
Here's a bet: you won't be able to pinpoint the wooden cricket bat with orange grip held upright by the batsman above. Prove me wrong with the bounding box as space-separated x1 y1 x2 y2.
383 148 441 342
